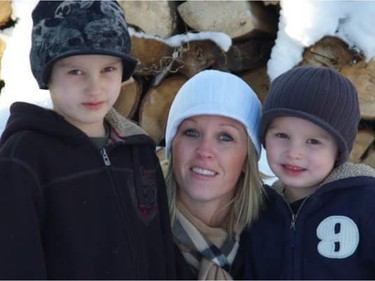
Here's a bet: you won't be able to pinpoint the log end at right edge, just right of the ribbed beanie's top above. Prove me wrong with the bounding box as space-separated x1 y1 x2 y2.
340 60 375 120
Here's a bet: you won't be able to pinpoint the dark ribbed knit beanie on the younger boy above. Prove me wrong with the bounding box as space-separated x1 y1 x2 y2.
261 66 361 166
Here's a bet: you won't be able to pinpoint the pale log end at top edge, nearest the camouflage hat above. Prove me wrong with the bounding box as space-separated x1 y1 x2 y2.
119 0 178 38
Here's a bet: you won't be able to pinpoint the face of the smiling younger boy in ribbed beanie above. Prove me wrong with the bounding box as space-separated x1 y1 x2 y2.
265 117 338 202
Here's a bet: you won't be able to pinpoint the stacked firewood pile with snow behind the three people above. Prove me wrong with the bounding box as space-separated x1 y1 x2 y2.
0 0 375 168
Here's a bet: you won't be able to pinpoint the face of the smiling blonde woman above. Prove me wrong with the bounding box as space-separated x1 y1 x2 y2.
172 115 248 215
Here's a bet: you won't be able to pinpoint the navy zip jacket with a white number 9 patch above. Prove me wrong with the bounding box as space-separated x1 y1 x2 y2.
245 163 375 280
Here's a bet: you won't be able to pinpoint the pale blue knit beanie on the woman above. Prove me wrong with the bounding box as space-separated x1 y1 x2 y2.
165 70 262 159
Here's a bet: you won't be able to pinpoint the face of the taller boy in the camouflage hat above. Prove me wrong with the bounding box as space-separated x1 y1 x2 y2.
49 55 123 137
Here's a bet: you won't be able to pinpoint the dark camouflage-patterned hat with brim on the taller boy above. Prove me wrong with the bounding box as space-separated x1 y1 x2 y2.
30 0 137 89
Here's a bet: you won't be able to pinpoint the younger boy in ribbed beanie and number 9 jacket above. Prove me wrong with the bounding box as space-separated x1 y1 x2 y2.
245 66 375 280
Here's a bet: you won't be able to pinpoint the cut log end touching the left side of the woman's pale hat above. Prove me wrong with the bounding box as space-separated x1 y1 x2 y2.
139 74 187 144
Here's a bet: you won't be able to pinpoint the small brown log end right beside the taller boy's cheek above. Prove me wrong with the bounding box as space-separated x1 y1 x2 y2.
113 77 142 119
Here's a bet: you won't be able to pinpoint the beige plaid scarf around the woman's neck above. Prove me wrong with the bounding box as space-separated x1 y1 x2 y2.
173 204 239 280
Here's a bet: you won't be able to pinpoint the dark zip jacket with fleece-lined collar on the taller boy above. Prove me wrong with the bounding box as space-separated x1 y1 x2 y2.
0 103 176 279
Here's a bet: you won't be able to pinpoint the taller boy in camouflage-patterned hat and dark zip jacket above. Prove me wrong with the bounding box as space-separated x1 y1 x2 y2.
0 0 181 280
